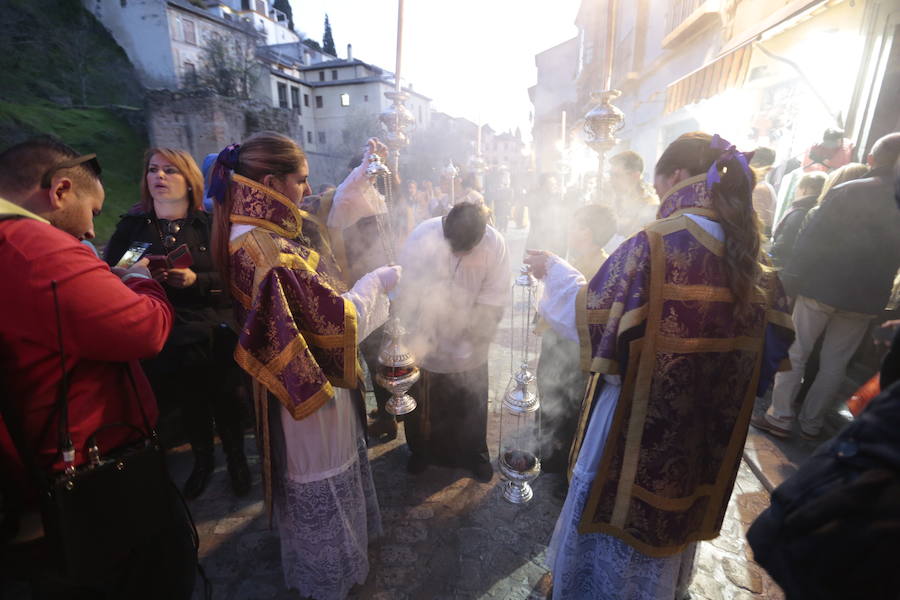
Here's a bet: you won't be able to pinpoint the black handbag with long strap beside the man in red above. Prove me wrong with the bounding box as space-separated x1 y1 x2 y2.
4 281 202 595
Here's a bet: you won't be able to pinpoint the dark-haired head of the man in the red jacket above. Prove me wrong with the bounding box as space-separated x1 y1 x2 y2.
0 137 104 240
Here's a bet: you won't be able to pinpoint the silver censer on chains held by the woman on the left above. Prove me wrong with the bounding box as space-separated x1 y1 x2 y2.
366 153 419 416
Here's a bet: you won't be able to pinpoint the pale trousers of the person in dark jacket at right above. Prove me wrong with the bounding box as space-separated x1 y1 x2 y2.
766 296 873 435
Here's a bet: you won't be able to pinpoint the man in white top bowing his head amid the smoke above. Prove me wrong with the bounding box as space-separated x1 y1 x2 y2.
398 203 510 482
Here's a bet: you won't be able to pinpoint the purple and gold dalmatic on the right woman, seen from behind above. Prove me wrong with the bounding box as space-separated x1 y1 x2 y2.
572 174 793 557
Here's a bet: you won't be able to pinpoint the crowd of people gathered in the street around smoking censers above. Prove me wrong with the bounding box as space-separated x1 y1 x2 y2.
0 123 900 600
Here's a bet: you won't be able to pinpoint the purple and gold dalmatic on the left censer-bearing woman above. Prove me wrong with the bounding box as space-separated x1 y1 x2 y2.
229 174 360 502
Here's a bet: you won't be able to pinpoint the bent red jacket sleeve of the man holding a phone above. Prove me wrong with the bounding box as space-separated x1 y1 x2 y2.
8 227 174 362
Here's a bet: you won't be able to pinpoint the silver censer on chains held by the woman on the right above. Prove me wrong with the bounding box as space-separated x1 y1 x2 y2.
498 265 541 504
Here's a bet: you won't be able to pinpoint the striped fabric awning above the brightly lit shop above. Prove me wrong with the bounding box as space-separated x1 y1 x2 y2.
665 43 753 114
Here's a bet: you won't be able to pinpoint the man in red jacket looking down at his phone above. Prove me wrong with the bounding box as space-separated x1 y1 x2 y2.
0 138 193 597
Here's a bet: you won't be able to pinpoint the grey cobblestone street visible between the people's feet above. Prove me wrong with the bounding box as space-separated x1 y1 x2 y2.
173 230 808 600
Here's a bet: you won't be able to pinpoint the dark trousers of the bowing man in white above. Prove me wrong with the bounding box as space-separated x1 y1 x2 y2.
403 363 491 468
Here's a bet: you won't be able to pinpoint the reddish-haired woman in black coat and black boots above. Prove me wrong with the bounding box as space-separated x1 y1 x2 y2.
105 148 251 498
